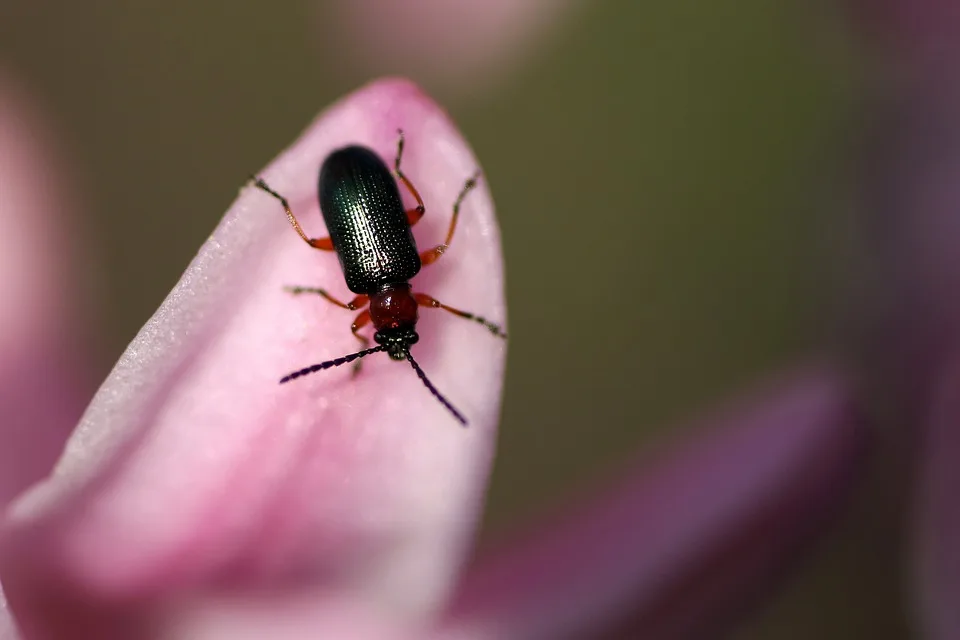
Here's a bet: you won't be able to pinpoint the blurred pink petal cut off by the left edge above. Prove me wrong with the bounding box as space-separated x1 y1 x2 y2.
0 73 92 506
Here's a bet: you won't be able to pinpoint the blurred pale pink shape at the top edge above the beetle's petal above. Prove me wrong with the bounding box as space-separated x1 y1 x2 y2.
319 0 580 95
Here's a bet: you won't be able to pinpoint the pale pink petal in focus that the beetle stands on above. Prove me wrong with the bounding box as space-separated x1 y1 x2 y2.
2 80 506 632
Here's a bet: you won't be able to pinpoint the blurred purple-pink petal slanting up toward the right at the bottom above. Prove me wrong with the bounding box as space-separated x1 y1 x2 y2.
438 370 865 640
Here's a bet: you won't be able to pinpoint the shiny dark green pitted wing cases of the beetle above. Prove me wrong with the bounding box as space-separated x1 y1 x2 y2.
319 146 420 293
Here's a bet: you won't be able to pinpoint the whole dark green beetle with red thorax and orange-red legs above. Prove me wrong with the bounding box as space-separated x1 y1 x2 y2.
250 130 507 426
